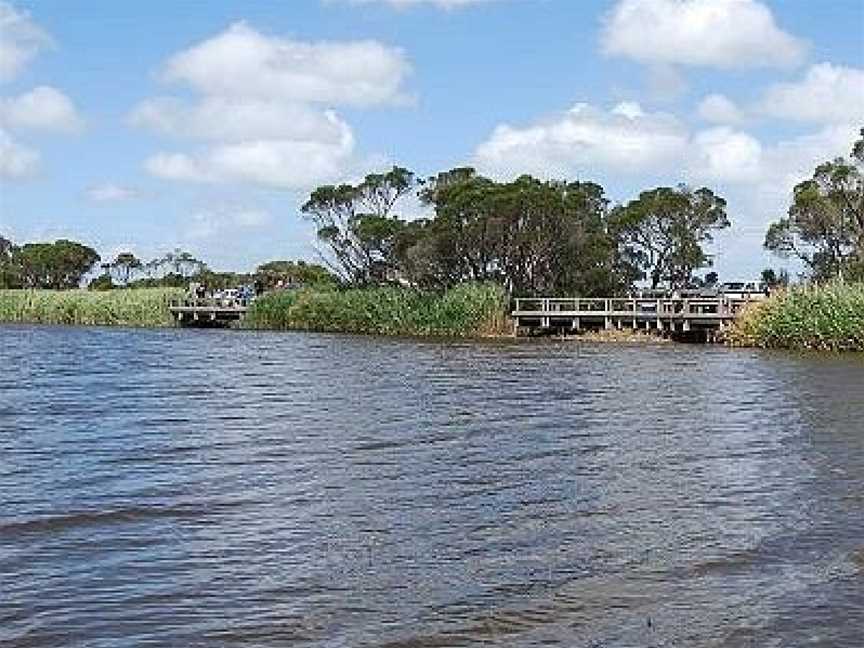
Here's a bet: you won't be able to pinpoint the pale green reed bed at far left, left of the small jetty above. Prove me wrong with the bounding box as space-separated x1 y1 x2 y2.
0 288 184 326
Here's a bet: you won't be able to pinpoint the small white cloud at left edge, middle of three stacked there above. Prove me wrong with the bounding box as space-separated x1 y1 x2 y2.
0 86 84 133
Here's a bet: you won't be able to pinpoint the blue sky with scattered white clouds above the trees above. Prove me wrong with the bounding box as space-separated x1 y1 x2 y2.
0 0 864 280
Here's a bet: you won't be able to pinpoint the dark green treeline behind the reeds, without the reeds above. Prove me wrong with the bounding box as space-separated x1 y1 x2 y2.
0 130 864 296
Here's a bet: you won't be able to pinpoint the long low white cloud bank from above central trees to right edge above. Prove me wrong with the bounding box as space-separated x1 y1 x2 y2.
473 102 857 195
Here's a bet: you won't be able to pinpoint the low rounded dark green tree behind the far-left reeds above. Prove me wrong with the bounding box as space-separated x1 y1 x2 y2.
14 239 99 290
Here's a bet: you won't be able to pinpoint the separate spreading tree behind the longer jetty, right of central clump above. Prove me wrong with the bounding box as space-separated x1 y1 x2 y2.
611 186 730 288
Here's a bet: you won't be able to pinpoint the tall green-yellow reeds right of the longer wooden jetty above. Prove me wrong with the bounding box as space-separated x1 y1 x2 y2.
729 283 864 351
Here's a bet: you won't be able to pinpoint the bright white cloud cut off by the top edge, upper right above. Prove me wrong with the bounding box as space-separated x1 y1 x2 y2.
602 0 806 68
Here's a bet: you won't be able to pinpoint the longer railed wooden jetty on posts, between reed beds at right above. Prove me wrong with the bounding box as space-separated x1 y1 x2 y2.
512 296 756 341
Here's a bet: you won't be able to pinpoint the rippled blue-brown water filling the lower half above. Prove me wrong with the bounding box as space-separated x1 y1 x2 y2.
0 327 864 648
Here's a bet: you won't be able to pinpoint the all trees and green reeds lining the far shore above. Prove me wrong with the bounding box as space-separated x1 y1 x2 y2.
0 131 864 350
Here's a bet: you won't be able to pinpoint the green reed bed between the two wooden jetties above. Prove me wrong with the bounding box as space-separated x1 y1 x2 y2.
245 284 511 337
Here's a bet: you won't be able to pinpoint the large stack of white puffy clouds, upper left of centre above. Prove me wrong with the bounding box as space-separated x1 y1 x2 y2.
135 23 410 189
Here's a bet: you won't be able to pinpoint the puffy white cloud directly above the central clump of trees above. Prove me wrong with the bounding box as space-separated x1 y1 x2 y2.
475 102 687 176
